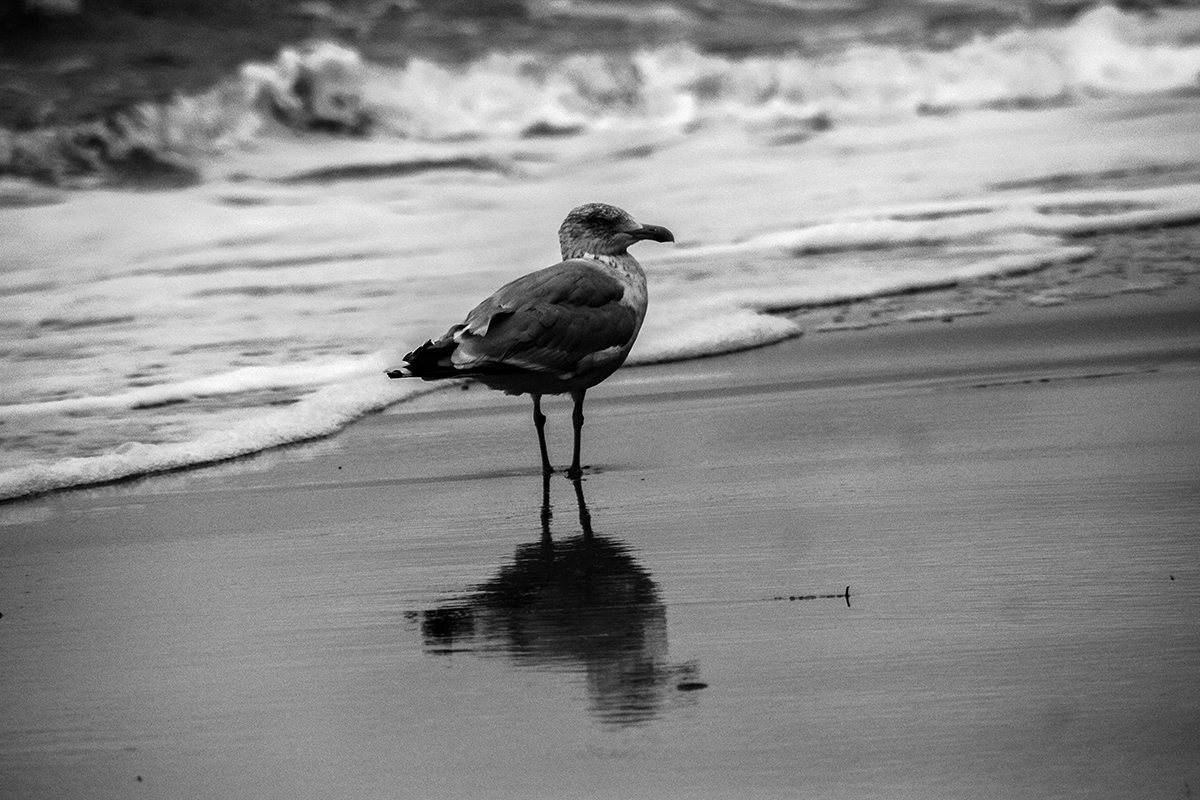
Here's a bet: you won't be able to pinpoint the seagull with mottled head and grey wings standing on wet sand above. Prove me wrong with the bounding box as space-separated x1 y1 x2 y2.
388 203 674 479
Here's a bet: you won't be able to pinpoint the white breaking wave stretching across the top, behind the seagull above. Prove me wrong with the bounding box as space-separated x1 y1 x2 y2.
9 6 1200 186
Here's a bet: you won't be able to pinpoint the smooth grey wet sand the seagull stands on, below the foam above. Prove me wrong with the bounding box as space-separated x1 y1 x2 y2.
0 284 1200 799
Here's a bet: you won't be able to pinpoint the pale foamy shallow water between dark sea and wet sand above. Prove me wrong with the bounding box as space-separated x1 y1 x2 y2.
0 8 1200 499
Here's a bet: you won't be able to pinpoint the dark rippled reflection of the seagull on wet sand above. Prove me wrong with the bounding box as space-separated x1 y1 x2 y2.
420 475 703 726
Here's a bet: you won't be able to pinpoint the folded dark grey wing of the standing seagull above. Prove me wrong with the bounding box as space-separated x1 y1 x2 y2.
452 259 641 377
